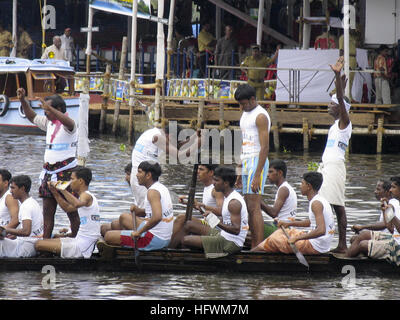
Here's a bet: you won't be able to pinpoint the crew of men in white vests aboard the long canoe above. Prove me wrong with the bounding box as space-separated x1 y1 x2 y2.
0 57 400 265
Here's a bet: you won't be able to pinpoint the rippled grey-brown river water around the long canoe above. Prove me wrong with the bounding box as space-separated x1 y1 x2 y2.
0 134 400 300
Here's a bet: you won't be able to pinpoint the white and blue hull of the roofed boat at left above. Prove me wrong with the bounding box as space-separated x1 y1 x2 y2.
0 97 79 134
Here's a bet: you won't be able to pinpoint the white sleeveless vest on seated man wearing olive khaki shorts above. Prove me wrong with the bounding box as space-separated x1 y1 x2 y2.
221 190 249 247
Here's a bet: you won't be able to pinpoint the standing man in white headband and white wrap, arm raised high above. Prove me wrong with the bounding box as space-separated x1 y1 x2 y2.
318 57 352 253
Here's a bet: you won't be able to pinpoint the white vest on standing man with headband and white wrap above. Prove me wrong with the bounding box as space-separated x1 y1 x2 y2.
322 120 353 163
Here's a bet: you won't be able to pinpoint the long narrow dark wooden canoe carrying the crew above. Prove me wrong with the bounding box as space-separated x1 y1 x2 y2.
0 243 400 276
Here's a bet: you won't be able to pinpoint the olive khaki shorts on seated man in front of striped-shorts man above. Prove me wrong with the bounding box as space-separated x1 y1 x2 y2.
201 229 240 259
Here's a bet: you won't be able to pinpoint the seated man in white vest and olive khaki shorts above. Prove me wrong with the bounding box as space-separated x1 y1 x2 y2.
182 167 249 258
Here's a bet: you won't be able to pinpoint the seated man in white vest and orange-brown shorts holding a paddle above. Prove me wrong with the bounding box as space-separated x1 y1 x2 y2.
252 172 335 254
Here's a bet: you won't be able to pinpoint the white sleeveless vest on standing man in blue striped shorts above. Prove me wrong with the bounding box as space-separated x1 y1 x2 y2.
240 105 271 160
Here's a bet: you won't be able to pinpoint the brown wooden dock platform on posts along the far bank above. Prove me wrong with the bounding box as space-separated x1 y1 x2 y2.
90 95 400 154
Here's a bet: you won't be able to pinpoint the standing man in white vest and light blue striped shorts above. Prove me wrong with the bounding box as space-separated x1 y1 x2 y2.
235 84 271 248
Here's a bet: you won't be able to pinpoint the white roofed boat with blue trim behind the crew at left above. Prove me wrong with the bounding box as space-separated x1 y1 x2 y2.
0 57 79 134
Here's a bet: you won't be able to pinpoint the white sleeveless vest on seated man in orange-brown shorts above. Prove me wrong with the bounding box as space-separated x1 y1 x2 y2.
308 194 335 253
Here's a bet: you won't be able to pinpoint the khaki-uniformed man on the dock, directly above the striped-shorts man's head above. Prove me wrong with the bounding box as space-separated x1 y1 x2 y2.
240 44 280 101
